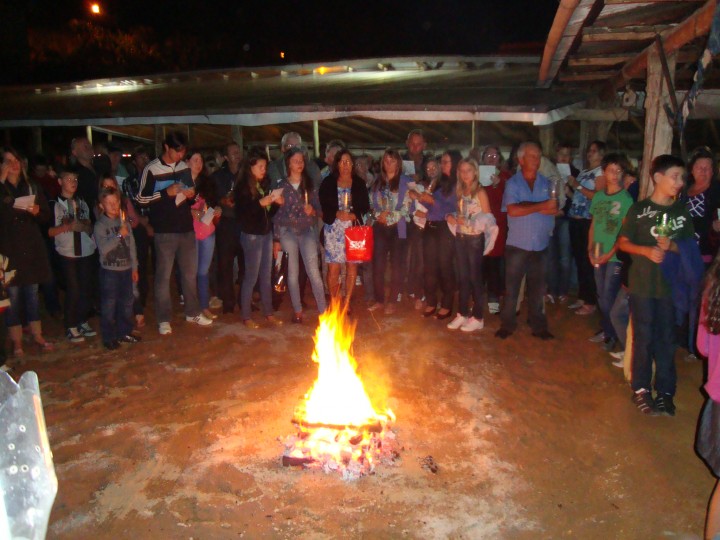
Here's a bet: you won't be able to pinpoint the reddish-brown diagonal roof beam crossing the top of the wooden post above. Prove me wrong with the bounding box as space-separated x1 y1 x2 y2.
610 0 718 91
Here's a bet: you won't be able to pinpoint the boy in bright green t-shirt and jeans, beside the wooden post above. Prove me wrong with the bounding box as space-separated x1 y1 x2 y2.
588 154 633 351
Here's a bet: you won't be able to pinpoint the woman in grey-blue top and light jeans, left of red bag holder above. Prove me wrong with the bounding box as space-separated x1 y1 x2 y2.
273 148 326 323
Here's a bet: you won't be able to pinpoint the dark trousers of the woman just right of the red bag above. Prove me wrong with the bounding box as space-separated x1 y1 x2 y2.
373 223 407 304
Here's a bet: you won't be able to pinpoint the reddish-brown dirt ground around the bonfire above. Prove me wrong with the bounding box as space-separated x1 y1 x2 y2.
5 294 714 540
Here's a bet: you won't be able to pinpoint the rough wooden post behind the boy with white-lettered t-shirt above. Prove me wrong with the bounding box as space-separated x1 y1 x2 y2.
638 47 675 199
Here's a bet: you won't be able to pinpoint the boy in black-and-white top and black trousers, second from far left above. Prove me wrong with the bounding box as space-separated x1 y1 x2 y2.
48 169 96 343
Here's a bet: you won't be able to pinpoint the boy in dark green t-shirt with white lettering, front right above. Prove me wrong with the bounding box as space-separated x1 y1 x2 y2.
618 154 694 416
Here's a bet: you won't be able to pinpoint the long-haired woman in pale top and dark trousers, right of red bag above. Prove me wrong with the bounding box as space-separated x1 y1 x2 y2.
368 148 412 315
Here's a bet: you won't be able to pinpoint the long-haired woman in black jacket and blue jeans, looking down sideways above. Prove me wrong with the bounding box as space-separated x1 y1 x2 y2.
233 148 284 329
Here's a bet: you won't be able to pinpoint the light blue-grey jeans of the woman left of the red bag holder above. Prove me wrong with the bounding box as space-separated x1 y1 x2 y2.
279 227 327 313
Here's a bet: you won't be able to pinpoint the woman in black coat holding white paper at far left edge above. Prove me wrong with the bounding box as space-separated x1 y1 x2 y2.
0 148 52 356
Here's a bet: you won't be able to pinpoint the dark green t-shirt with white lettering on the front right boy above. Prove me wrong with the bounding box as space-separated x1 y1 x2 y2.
620 198 695 298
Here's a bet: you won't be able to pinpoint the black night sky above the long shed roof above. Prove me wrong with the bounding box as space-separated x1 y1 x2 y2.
7 0 558 83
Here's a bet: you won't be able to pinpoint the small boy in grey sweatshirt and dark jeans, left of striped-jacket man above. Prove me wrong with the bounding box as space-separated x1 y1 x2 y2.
94 188 140 350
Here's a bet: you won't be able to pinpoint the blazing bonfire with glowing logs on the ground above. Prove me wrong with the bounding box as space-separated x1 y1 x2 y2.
283 303 397 479
